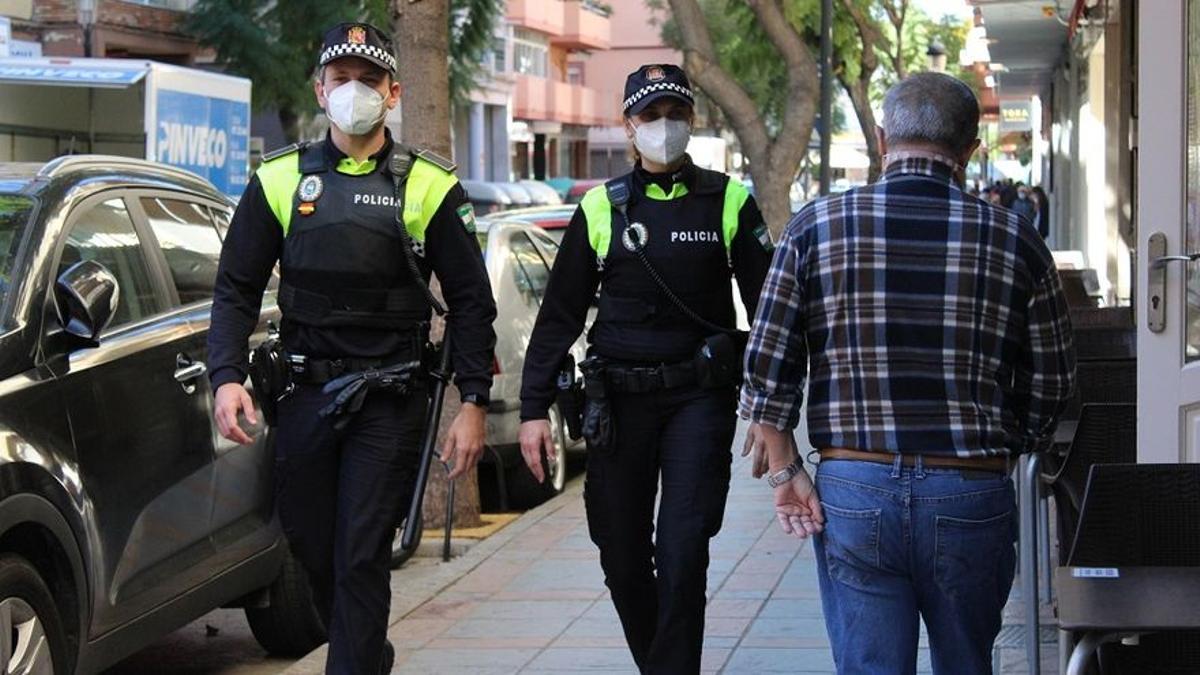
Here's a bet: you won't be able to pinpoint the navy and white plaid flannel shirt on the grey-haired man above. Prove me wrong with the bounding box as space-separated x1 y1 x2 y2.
739 156 1075 458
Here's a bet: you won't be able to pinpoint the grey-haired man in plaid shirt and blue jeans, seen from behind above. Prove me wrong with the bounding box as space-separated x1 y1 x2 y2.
740 73 1075 674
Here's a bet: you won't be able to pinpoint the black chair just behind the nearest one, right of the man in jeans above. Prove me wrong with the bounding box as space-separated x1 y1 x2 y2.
1042 402 1138 565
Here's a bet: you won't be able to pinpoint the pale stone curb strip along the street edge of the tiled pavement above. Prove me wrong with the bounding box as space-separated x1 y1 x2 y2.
281 476 583 675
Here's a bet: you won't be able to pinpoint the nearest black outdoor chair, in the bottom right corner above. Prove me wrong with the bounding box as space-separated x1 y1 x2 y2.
1055 464 1200 675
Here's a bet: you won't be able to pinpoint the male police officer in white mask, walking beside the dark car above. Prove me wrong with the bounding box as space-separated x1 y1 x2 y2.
209 24 496 675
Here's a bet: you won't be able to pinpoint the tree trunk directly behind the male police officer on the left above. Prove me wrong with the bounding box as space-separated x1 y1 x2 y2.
395 0 480 527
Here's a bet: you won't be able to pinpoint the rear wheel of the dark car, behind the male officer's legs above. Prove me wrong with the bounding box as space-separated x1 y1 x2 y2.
246 552 328 657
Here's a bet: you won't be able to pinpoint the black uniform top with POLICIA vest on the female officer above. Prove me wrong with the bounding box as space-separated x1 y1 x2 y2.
521 163 773 420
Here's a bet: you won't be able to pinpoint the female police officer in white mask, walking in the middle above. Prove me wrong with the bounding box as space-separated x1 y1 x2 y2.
521 65 770 673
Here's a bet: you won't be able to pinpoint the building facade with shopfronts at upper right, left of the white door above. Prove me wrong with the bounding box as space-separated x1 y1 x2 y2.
977 0 1132 305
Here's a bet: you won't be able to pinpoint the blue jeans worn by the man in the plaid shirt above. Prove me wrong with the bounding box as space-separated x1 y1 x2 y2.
815 460 1016 675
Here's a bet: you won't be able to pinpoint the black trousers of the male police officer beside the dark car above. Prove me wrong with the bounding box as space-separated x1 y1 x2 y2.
275 384 427 675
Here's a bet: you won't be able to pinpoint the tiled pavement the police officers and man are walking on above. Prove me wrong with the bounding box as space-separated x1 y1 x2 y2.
288 420 1057 675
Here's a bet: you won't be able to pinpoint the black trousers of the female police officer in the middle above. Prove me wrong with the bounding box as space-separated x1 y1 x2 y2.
584 387 736 675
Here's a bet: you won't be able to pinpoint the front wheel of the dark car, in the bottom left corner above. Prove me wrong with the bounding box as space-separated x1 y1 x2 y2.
0 555 72 675
